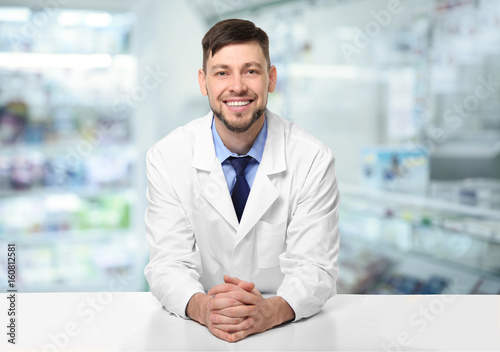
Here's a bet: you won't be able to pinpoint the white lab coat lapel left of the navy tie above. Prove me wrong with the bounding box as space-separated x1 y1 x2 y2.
192 112 238 230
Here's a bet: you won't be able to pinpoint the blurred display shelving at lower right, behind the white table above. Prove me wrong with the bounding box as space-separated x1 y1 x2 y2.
339 184 500 294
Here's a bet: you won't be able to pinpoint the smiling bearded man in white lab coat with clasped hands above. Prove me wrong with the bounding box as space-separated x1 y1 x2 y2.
145 19 339 342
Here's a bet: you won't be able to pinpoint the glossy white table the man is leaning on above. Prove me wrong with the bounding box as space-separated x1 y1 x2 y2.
0 292 500 352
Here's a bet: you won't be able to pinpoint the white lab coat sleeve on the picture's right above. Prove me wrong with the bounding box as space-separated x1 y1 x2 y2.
277 153 340 321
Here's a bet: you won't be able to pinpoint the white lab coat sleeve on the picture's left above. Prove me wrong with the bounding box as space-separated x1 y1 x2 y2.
144 147 204 319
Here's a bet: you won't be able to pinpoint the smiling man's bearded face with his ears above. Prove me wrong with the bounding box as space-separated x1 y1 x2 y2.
198 42 276 133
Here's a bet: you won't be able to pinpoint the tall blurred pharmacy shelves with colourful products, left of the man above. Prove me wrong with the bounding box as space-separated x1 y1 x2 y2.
0 8 145 292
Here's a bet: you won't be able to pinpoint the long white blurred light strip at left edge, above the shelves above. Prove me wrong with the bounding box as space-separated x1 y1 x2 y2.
0 53 113 69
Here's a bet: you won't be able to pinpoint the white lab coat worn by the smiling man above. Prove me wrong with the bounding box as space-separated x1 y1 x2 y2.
145 110 340 320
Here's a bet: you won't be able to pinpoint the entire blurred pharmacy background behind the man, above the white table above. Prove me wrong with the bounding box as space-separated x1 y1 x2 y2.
0 0 500 294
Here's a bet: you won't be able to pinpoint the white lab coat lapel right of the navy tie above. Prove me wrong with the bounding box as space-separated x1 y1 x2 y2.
236 110 286 243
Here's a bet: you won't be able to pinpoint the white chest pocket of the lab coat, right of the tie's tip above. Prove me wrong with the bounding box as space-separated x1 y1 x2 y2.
256 221 286 269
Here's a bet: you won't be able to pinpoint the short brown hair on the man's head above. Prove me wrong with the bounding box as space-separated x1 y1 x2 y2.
201 19 271 72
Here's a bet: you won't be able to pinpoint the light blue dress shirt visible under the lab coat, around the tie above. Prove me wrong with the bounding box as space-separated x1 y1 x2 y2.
212 116 267 194
